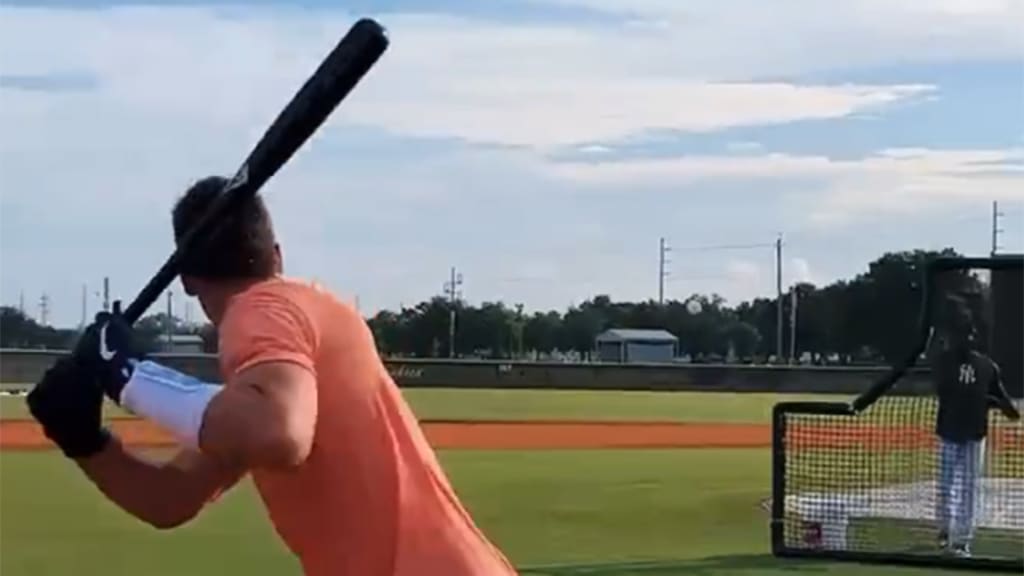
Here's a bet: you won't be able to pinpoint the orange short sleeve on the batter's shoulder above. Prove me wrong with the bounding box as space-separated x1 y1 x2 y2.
218 290 317 380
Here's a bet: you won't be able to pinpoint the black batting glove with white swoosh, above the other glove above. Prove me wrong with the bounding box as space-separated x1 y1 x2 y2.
74 301 145 405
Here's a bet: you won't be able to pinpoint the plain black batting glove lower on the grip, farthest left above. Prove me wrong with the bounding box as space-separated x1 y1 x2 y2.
27 357 111 458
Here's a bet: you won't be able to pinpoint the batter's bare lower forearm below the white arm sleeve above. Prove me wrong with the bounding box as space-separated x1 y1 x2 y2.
76 438 245 529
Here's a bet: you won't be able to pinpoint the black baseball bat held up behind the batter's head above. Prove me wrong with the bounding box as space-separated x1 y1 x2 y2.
124 18 389 324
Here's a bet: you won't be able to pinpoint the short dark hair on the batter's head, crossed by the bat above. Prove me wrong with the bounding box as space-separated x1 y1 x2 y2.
172 176 278 280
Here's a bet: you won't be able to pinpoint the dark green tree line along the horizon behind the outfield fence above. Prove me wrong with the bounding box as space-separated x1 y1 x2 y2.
0 249 977 363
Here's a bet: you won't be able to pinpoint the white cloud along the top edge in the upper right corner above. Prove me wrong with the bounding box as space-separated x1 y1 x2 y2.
548 0 1024 72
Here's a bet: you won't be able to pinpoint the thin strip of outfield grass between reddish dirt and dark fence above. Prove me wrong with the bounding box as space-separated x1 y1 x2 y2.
0 388 850 423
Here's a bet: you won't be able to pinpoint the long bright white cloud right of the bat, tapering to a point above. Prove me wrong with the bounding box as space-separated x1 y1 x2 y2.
356 79 931 149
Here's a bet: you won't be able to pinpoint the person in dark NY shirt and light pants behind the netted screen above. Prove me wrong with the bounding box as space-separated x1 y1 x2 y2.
930 297 1020 557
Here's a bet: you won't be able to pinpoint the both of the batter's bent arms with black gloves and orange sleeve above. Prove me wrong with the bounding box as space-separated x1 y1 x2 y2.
45 299 315 528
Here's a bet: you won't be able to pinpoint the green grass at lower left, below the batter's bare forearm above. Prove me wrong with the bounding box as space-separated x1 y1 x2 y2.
0 452 299 576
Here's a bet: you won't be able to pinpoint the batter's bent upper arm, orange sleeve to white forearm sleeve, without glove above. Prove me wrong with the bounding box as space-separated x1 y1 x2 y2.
115 286 317 469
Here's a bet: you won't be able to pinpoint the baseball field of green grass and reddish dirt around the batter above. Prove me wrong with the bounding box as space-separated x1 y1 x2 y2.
0 389 978 576
